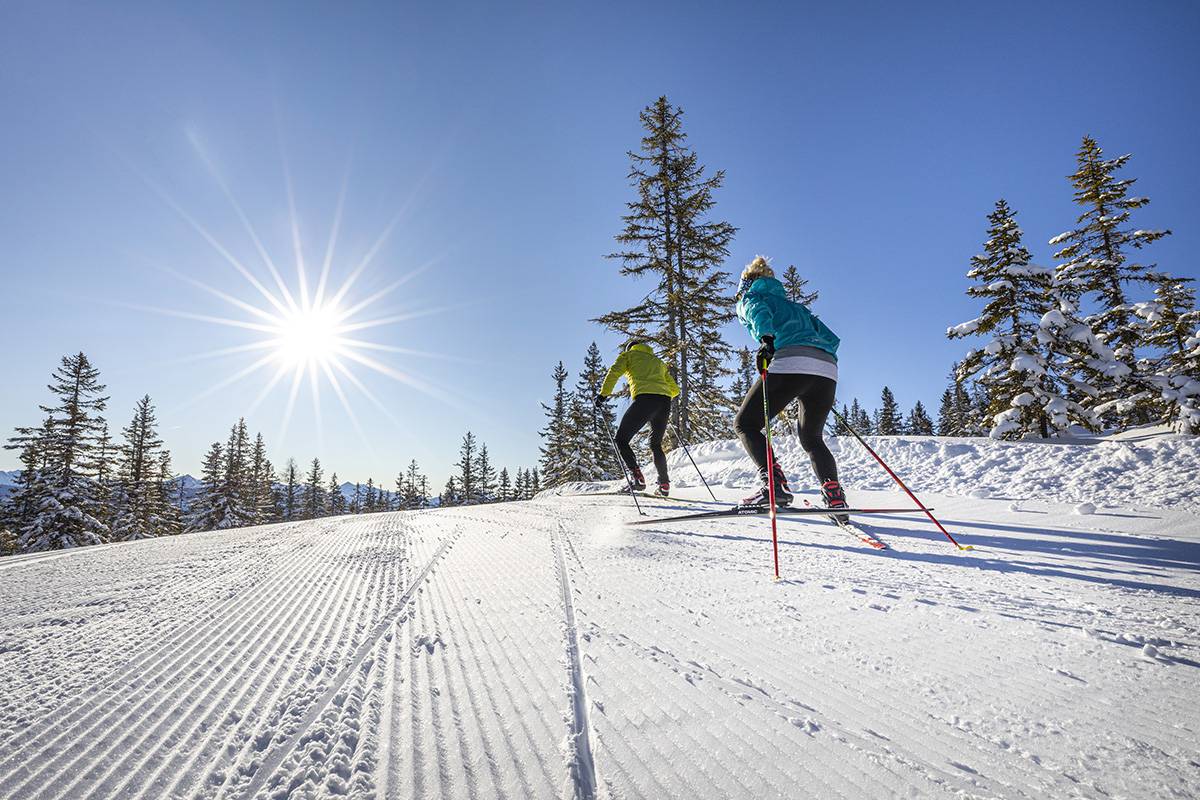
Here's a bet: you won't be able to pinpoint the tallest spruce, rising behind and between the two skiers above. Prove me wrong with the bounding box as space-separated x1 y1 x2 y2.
595 97 737 443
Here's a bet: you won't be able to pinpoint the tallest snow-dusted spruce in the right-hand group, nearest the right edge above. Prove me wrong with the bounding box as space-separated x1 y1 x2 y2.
1050 136 1171 426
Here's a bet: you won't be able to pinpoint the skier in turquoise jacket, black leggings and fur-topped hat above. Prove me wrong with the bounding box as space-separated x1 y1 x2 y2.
733 255 847 522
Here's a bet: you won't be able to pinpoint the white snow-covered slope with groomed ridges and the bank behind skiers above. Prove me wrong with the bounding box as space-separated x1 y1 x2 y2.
0 439 1200 800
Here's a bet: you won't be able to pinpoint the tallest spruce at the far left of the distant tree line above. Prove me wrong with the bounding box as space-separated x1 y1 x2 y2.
7 353 109 552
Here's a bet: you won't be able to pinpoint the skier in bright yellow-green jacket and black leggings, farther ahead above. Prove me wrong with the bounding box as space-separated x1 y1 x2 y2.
596 339 679 497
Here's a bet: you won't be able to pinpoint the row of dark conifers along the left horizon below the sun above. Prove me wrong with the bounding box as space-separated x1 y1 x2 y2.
0 353 541 555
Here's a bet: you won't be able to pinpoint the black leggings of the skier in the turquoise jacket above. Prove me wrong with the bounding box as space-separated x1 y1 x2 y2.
733 372 838 483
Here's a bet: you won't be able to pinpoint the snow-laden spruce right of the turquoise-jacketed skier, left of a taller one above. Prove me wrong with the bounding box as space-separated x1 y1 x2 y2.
943 199 1086 439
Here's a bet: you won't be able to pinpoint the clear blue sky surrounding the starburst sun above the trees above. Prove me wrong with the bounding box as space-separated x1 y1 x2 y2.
0 2 1200 486
